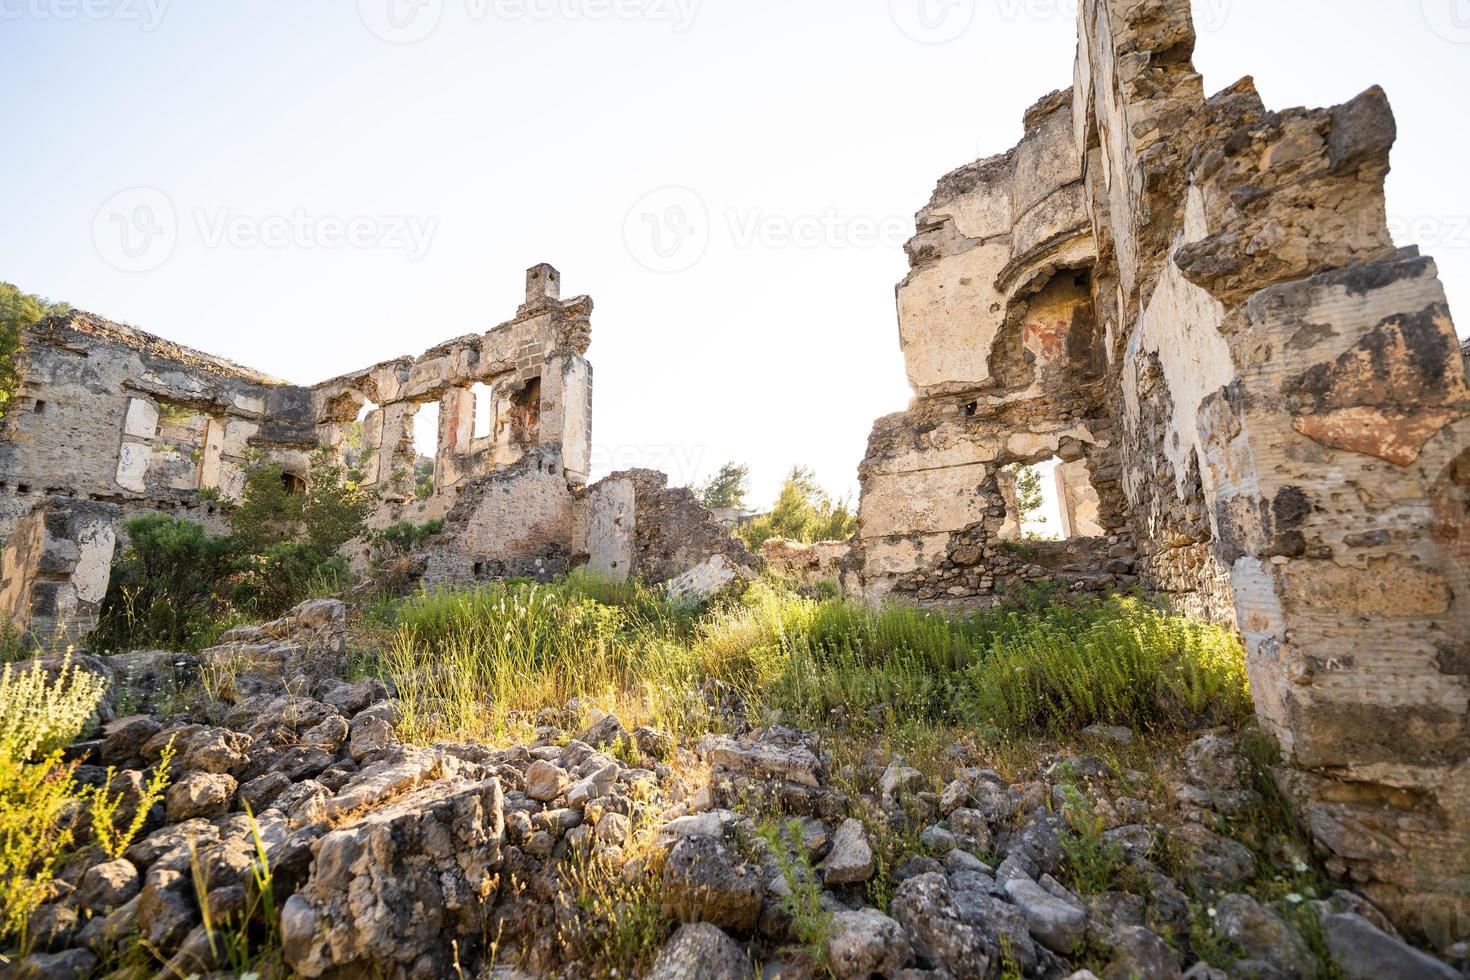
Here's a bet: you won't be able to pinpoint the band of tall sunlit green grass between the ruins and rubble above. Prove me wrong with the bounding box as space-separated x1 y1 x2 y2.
367 576 1250 741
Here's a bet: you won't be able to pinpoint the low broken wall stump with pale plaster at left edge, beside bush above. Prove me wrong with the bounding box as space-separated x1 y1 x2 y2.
0 497 119 652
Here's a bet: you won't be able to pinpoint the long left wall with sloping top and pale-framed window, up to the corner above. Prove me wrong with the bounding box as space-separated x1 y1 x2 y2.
0 311 315 536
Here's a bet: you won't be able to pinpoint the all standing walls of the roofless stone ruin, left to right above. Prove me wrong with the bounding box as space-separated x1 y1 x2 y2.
0 0 1470 937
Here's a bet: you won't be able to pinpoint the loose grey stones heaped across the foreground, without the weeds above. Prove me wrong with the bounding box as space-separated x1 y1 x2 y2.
8 611 1458 980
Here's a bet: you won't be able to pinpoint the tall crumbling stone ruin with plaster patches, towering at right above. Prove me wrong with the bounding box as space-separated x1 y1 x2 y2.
856 0 1470 942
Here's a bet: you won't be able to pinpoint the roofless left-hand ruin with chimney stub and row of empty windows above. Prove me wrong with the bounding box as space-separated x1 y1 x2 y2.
0 266 592 645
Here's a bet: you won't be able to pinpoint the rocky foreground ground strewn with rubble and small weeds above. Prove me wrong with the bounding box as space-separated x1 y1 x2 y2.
6 601 1470 980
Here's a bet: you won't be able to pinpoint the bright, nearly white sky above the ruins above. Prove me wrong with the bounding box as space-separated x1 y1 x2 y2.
0 0 1470 502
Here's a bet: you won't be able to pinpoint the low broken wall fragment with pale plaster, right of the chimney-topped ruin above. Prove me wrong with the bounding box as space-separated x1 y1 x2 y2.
579 470 759 594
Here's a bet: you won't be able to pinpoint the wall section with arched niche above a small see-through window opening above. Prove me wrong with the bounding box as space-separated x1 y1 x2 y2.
858 93 1138 610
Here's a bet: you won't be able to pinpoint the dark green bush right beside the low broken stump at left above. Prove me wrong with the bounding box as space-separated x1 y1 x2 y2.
90 514 234 652
